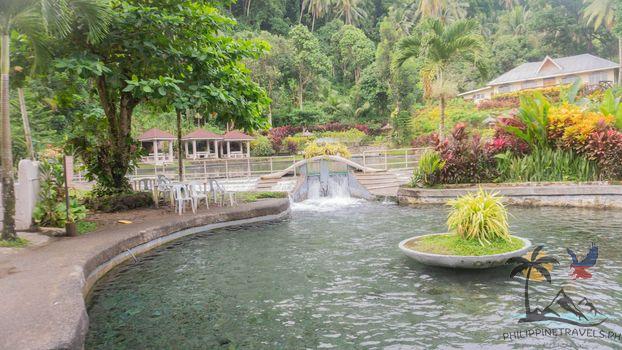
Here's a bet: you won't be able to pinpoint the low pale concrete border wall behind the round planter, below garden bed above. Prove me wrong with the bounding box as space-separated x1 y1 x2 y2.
397 182 622 208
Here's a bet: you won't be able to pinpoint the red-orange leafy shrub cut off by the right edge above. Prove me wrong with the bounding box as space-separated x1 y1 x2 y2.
580 125 622 180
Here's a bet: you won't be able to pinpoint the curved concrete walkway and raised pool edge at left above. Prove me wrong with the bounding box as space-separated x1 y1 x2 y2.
0 199 290 349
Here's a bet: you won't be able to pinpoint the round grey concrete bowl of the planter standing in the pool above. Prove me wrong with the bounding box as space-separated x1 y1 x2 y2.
399 233 531 269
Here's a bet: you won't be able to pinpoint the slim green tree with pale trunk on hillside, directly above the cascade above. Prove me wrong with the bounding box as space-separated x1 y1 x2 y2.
289 25 330 110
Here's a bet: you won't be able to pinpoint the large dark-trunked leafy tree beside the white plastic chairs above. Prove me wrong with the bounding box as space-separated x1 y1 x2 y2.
62 0 266 194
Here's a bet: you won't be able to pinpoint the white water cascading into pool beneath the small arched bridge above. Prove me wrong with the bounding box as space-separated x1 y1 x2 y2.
292 176 364 212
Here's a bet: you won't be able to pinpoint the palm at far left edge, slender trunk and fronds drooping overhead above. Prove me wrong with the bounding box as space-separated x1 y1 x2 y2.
0 0 111 239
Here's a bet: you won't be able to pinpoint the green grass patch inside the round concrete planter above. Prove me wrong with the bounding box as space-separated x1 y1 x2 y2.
406 233 524 256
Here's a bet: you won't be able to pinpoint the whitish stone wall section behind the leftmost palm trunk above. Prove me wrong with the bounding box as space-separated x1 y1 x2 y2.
0 159 39 230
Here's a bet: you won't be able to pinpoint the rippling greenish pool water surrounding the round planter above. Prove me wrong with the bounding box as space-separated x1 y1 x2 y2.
86 200 622 349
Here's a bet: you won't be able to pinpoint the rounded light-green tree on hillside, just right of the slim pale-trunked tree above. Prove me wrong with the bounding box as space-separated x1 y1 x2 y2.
332 24 375 83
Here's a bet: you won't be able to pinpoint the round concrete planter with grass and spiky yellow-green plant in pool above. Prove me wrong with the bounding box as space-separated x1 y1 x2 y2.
399 189 531 269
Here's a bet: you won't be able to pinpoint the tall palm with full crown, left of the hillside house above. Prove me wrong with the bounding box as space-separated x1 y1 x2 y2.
394 18 484 139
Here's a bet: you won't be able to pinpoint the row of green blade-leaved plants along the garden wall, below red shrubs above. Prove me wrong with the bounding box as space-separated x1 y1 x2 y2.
495 148 599 182
